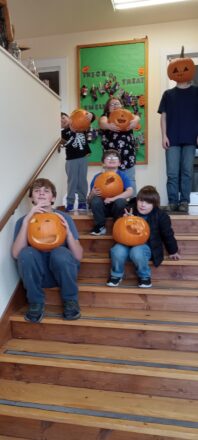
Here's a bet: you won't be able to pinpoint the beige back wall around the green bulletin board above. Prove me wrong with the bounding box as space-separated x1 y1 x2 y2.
19 19 198 203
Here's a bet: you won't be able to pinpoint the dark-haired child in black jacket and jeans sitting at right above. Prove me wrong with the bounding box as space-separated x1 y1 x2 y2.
107 185 180 288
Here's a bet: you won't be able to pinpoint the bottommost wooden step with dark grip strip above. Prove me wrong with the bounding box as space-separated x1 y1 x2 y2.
0 380 198 440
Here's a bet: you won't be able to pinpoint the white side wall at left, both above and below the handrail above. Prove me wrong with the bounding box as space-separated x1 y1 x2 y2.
0 48 62 316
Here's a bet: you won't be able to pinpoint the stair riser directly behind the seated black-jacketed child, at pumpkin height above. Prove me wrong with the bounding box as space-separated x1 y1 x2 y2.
80 238 198 256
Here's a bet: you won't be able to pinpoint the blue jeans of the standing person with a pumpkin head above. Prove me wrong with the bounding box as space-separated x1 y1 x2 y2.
166 145 195 204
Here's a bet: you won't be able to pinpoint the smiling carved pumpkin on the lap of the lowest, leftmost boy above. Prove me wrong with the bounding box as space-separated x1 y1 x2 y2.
28 212 67 251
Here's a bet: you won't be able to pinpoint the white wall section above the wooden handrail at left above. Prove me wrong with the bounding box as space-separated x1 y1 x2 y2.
0 45 60 218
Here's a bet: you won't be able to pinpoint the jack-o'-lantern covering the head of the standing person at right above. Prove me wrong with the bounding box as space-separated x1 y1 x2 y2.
167 46 195 83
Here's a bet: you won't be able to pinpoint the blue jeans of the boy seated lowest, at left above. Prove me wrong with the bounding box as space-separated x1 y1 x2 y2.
17 246 79 304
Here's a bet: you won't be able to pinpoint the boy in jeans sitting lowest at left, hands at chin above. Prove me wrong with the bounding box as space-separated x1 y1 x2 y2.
12 178 82 322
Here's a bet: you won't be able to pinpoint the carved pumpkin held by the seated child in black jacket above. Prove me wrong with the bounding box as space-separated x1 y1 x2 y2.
113 215 150 246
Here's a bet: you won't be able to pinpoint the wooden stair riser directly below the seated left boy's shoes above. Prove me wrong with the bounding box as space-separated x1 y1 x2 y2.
12 321 198 352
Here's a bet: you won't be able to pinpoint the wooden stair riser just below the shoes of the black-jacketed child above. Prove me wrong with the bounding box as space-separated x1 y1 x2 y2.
45 287 198 313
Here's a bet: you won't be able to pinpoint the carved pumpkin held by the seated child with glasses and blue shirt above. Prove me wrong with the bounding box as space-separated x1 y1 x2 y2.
94 171 124 199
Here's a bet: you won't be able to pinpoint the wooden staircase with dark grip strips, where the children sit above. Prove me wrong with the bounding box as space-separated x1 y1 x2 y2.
0 214 198 440
